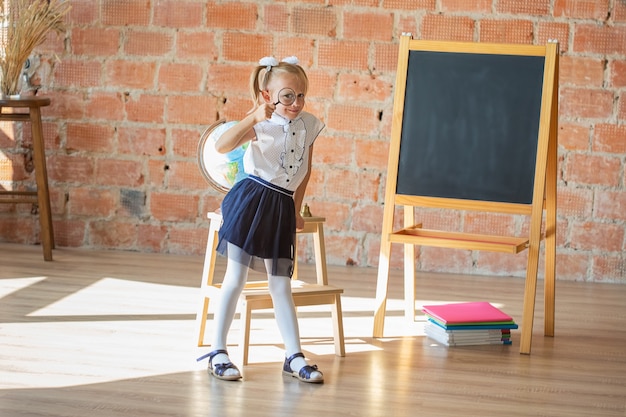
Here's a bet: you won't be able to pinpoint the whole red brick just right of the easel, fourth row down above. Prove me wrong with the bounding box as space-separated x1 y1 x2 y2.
559 87 613 119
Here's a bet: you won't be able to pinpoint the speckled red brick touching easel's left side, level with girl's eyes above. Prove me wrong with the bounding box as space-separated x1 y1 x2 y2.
337 74 393 102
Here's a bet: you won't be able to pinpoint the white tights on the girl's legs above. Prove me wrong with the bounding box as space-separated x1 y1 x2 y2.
211 243 306 372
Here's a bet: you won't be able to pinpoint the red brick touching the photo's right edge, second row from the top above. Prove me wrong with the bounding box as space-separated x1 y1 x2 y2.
573 24 626 55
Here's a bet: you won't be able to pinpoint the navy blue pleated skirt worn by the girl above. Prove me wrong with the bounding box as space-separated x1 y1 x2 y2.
217 176 296 277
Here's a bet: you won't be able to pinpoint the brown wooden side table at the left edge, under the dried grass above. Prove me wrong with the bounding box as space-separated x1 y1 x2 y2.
0 96 54 261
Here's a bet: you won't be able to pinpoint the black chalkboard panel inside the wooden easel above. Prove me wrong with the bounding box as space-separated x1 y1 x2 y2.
396 50 545 204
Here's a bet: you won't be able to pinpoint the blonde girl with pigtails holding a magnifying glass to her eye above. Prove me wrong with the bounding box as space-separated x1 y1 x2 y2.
200 57 324 383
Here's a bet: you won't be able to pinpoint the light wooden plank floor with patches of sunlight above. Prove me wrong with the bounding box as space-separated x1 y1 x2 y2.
0 240 626 417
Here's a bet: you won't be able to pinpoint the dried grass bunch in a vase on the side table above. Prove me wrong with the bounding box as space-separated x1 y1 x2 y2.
0 0 70 96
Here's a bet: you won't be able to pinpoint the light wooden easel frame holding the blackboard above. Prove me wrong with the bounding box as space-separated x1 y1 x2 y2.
373 35 559 354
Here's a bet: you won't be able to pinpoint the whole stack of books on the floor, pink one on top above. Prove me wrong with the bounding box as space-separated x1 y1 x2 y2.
422 301 518 346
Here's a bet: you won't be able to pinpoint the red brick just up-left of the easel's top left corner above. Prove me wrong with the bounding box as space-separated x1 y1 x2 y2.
343 11 393 42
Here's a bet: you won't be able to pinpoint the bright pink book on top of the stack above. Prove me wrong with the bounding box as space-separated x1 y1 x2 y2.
422 301 513 324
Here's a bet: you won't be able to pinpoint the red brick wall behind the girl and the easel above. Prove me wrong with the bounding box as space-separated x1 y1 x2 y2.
0 0 626 283
